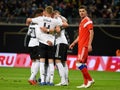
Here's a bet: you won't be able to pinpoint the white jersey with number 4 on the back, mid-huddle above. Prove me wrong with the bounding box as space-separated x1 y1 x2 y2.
32 16 62 45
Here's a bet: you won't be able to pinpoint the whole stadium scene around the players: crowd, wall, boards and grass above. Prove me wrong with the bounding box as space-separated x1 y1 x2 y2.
0 0 120 90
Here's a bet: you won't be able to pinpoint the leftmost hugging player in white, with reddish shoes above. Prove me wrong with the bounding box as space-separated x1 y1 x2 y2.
27 8 43 85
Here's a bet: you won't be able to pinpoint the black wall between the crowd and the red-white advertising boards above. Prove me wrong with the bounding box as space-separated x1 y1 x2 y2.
0 24 120 56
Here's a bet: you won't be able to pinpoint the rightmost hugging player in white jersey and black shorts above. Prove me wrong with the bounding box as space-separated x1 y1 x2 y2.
54 10 68 86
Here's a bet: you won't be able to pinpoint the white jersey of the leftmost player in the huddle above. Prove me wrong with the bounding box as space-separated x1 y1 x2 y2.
27 23 40 47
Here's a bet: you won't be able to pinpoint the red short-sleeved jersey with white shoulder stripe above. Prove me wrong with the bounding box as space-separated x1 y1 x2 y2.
78 17 93 53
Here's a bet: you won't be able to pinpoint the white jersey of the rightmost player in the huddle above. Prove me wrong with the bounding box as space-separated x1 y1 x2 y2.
55 17 68 44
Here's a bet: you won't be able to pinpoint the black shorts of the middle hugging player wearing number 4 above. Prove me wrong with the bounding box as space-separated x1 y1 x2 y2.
39 43 54 59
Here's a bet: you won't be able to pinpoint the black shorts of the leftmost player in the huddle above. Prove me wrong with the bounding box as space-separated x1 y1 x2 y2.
28 46 39 60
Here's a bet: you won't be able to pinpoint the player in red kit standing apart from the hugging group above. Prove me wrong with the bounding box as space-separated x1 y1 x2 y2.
69 6 94 88
